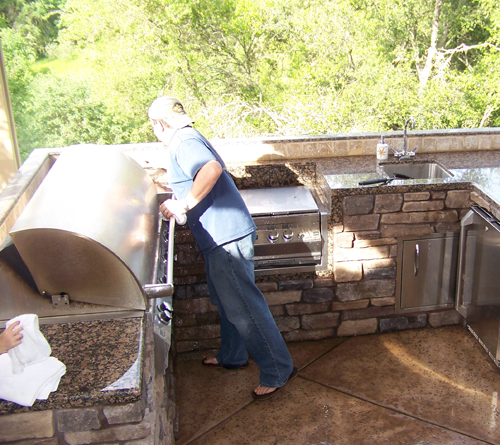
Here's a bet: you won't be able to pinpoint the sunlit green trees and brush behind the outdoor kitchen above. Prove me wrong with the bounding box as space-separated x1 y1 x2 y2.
0 0 500 161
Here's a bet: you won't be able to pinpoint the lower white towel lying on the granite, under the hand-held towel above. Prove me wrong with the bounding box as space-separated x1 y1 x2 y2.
0 354 66 406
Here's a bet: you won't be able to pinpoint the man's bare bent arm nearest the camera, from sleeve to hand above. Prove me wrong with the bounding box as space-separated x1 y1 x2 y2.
160 160 222 218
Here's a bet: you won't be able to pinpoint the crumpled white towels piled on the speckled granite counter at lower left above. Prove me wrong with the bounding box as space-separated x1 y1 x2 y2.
0 314 66 406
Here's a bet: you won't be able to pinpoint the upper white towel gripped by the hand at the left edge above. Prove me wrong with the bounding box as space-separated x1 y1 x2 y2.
6 314 52 374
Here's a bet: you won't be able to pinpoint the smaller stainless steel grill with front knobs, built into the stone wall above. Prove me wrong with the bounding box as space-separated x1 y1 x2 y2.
240 186 328 275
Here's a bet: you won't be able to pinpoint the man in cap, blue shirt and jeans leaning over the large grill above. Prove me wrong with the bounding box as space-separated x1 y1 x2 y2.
148 96 297 400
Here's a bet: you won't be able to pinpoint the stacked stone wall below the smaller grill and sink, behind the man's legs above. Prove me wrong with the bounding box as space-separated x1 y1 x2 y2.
174 186 477 352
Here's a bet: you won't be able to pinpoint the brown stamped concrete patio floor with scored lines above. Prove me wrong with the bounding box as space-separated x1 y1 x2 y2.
175 326 500 445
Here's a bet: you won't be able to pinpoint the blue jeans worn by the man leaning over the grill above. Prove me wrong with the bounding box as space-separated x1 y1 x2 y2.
205 232 293 388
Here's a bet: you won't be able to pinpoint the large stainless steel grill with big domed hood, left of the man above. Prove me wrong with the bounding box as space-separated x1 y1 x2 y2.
0 147 173 323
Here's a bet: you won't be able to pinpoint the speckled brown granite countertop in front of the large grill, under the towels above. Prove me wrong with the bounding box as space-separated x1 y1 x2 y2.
0 318 145 415
